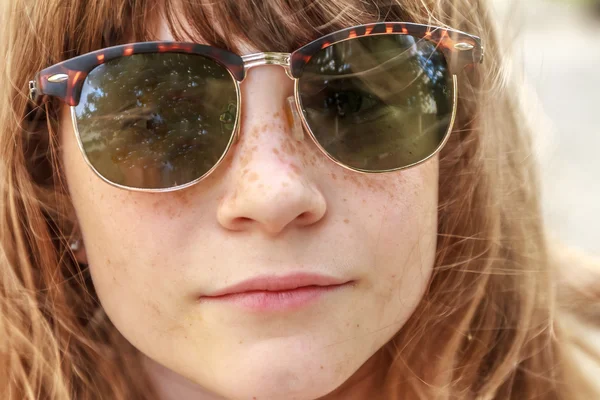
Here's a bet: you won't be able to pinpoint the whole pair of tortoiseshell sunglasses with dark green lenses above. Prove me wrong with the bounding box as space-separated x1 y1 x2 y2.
29 22 483 192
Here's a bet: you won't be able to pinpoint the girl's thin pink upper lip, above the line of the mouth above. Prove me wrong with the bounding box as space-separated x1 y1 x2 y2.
206 272 349 297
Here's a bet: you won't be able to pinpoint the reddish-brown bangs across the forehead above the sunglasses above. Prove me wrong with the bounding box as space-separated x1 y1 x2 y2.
57 0 418 58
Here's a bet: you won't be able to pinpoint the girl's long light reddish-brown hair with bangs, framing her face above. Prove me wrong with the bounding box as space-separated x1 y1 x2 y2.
0 0 600 400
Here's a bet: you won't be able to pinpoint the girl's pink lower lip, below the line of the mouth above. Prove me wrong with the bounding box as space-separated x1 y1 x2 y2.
200 283 347 312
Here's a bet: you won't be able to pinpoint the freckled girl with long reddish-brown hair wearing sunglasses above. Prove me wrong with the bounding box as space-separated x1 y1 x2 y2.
0 0 599 400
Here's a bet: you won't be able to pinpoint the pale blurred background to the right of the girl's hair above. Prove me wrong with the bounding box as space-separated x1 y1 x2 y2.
493 0 600 256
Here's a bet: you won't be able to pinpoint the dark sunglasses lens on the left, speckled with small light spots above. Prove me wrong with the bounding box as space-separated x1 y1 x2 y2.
73 53 237 189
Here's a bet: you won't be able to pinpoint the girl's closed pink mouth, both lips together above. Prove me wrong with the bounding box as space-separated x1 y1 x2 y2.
199 273 354 312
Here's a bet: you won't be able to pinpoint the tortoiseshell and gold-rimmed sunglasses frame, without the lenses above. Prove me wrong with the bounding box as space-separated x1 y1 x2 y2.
29 22 484 192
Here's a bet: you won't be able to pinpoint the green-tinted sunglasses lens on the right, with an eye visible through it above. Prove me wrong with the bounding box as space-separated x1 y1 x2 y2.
298 34 454 171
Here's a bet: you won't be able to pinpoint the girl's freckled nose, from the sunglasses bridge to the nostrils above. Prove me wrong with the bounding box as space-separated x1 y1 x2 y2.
217 66 327 235
